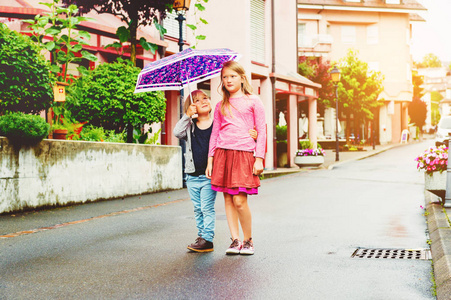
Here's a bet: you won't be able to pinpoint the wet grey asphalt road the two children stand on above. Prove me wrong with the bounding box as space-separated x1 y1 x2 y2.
0 142 435 300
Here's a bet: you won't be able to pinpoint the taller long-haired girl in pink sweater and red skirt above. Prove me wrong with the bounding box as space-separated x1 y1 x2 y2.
205 61 266 255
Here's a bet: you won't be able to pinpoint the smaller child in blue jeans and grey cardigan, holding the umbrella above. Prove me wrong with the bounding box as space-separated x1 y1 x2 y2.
174 90 257 252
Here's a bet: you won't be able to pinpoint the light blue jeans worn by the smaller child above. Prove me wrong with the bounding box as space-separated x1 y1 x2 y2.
186 174 216 242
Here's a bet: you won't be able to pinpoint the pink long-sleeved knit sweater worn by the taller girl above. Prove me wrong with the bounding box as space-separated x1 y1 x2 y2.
208 95 266 158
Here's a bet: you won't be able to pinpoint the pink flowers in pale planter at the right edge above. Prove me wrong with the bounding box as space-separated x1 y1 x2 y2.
415 145 448 195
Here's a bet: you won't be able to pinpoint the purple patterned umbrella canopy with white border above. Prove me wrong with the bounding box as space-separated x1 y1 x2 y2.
135 48 240 93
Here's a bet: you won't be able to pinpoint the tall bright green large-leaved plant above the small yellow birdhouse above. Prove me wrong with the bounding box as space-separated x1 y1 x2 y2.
25 0 97 82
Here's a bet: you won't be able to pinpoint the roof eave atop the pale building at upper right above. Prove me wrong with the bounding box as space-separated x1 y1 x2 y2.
298 0 427 11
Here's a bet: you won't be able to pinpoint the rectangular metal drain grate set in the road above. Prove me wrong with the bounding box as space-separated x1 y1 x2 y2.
351 248 432 260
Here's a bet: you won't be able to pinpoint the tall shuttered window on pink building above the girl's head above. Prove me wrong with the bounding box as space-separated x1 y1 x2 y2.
251 0 265 63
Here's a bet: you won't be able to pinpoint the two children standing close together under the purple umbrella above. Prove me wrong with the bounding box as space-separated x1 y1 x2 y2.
174 61 266 254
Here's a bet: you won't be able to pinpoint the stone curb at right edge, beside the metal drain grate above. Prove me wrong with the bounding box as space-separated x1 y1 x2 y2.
424 191 451 300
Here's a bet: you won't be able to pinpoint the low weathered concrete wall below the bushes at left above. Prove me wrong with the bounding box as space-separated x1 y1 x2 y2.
0 137 183 213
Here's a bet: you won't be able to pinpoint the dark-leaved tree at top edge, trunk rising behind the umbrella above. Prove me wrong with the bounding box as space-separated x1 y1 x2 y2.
62 0 174 66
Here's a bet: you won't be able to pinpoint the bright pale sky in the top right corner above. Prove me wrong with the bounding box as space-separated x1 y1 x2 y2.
411 0 451 63
